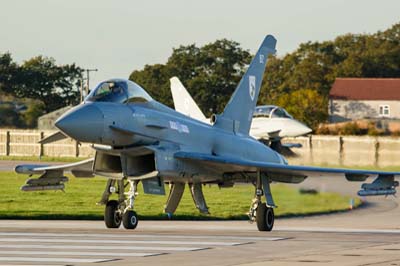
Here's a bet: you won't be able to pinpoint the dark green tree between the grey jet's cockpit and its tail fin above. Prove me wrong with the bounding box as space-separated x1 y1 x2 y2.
129 39 251 115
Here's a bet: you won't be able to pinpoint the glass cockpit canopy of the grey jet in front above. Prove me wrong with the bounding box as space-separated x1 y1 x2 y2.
85 79 153 103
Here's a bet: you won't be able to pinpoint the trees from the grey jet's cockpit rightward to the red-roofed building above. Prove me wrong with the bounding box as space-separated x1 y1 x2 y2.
129 24 400 129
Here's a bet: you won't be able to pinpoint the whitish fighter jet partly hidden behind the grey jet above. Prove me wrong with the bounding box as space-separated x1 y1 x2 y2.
170 77 312 155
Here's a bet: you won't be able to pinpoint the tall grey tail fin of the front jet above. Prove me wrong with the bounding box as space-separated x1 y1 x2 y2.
214 35 276 135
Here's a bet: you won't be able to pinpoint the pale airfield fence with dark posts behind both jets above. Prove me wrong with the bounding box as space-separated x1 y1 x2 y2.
0 129 400 167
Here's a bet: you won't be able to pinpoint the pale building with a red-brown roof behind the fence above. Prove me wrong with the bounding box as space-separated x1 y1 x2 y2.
329 78 400 122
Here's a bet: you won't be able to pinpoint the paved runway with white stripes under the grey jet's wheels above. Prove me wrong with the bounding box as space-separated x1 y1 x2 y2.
0 162 400 266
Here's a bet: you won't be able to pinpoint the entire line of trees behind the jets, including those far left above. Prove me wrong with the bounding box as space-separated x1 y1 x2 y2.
0 23 400 128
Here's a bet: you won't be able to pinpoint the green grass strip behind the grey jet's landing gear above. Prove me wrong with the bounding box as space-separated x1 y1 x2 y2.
0 172 360 220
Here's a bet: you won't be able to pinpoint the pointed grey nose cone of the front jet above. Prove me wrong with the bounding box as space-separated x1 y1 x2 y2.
55 104 104 143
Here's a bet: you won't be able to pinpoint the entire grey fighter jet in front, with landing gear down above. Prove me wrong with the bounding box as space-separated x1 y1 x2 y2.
15 35 400 231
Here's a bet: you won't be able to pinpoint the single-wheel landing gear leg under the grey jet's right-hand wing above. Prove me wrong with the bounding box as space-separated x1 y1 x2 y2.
248 172 276 231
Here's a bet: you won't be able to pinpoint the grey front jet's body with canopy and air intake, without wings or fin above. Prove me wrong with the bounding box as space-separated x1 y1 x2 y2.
56 80 287 182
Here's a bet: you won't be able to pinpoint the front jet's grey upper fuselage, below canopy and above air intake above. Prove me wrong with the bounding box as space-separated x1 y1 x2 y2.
56 101 282 163
